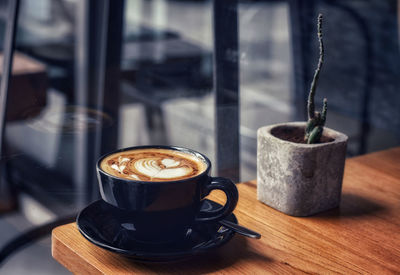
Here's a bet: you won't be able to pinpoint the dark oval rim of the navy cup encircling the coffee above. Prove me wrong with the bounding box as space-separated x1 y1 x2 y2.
96 145 211 184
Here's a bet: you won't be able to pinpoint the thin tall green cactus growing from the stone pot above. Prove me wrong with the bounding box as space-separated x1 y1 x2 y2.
304 14 328 144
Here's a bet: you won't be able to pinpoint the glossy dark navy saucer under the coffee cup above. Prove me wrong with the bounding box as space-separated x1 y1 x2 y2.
76 199 237 263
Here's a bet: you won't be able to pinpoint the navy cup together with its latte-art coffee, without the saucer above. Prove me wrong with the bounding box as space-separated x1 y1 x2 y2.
96 146 238 242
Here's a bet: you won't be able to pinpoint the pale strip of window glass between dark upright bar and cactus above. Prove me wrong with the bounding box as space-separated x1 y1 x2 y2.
239 1 295 181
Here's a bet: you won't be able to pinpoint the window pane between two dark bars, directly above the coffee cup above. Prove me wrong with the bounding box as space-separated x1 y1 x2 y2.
119 0 215 160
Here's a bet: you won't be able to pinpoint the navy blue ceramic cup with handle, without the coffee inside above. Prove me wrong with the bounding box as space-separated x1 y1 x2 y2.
96 146 238 242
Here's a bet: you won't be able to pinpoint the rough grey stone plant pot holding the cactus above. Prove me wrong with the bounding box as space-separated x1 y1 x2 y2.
257 122 348 216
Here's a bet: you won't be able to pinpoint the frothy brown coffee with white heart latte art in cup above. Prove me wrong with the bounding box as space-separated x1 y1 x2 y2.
100 148 207 182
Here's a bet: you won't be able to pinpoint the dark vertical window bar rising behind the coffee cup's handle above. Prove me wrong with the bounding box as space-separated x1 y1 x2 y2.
213 0 240 182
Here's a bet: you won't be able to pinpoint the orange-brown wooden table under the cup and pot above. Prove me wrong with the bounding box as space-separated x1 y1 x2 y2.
52 147 400 274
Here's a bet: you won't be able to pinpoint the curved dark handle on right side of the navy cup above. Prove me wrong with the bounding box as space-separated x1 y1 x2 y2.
196 177 239 222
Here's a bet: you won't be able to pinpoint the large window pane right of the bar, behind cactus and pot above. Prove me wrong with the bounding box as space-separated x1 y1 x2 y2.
239 1 400 180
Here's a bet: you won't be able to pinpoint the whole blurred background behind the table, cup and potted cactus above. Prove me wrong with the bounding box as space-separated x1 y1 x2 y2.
0 0 400 274
